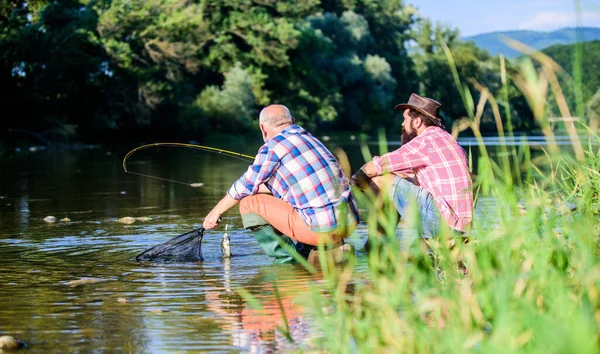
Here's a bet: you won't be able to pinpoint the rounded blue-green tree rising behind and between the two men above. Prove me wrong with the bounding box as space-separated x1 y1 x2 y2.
267 7 406 130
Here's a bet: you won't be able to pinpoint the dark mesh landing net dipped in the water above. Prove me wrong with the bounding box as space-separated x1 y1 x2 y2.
135 227 204 262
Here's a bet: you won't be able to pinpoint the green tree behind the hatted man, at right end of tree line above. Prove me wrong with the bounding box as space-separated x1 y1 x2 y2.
410 19 533 131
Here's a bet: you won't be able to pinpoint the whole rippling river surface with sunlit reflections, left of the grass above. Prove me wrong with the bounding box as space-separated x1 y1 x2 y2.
0 135 564 353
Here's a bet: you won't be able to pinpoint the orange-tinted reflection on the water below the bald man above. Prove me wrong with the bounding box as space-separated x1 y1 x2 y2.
206 265 322 352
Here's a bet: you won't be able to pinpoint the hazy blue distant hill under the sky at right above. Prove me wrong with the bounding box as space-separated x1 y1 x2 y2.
463 27 600 58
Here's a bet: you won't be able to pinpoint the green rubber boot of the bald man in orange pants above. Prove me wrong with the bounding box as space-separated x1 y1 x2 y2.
242 214 294 264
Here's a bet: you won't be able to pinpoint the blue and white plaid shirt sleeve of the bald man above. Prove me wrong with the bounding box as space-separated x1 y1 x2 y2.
227 145 281 200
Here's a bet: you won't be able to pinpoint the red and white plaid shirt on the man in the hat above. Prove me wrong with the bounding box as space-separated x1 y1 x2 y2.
373 127 473 231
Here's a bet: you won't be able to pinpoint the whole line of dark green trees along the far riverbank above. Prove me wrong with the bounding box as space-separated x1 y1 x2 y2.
0 0 592 146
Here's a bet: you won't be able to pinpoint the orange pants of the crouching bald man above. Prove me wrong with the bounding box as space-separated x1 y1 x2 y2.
240 194 356 246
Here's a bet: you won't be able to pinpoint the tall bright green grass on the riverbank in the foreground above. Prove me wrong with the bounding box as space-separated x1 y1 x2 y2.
239 29 600 353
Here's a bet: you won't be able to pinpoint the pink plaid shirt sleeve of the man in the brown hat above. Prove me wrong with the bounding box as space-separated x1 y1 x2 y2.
373 137 427 174
